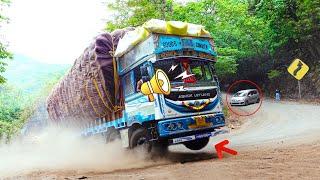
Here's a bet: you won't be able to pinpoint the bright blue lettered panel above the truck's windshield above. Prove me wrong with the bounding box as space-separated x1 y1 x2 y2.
155 36 217 56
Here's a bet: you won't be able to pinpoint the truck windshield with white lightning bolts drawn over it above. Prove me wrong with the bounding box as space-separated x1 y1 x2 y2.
154 58 214 85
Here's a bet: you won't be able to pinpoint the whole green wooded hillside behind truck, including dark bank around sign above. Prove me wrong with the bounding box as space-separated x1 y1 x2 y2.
106 0 320 98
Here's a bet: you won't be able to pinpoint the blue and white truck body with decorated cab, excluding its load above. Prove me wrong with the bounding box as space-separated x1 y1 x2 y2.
82 33 227 150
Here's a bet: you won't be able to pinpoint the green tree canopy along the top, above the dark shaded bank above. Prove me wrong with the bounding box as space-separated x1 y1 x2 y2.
106 0 320 80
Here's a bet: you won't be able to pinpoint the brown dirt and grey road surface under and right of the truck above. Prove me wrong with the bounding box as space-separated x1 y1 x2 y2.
2 101 320 179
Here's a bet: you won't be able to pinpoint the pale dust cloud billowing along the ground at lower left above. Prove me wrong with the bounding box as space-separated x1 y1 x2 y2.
0 127 165 177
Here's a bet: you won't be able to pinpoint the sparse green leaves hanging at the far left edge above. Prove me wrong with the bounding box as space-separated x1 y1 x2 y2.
0 0 12 84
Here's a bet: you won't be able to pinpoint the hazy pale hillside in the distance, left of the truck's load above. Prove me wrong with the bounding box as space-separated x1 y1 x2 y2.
0 55 68 140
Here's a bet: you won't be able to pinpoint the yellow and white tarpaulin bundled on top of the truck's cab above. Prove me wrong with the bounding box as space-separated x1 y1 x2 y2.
115 19 210 57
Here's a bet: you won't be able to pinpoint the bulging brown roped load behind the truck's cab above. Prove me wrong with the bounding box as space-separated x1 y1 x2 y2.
47 28 133 122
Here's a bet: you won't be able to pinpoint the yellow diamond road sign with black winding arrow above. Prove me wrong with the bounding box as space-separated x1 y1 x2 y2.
288 59 309 80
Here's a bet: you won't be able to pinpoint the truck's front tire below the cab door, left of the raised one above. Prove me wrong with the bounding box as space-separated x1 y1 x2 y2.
129 128 152 152
